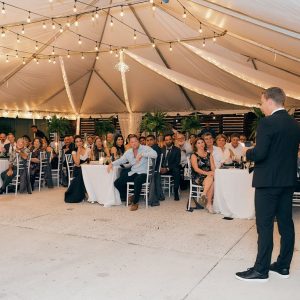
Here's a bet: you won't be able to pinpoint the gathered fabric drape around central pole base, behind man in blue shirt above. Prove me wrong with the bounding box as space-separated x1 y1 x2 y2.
118 113 143 139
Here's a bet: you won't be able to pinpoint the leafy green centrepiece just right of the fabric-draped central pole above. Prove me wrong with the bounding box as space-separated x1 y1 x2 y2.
141 112 170 136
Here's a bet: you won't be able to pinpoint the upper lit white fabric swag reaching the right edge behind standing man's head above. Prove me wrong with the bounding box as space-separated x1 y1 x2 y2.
181 42 300 100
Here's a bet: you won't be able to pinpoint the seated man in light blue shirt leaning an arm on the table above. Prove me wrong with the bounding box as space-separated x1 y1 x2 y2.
107 135 157 211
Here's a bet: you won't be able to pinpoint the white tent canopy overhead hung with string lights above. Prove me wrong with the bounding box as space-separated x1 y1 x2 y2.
0 0 300 117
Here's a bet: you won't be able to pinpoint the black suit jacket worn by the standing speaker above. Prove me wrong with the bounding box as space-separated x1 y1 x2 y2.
246 110 300 188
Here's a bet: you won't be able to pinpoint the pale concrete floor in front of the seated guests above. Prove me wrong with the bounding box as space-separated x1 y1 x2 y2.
0 189 300 300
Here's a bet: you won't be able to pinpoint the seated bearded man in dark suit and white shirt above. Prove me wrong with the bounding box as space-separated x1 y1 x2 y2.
160 134 181 201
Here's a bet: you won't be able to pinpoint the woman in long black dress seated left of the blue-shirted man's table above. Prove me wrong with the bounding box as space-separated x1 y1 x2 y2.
65 135 91 203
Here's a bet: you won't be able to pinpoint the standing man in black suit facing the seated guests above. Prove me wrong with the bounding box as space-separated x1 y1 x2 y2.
236 87 300 281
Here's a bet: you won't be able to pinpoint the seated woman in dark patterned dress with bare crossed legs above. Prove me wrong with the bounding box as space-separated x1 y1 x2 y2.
191 138 215 213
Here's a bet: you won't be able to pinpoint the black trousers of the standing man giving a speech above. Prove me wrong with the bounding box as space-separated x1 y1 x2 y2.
254 187 295 273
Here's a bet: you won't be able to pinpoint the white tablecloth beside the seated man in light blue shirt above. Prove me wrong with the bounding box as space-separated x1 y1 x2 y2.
81 162 122 207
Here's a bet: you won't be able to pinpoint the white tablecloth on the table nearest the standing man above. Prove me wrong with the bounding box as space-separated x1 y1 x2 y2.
214 169 255 219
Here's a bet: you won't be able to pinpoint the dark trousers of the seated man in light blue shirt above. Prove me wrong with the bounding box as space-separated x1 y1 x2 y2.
114 169 147 204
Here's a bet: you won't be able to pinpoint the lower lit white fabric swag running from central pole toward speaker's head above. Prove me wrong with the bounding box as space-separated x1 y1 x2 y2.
124 50 257 107
